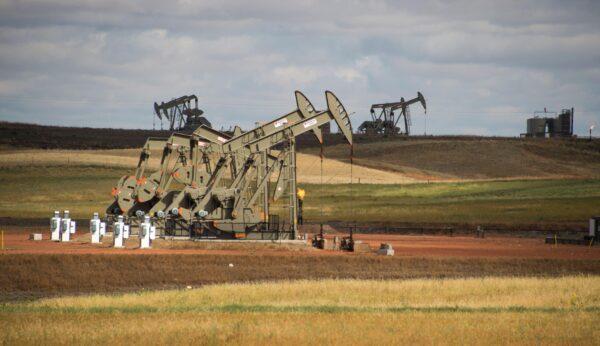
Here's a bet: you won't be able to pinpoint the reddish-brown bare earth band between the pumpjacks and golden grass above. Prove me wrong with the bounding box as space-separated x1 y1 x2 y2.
0 227 600 301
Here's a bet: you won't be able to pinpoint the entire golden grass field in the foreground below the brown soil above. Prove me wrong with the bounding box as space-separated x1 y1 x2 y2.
0 276 600 345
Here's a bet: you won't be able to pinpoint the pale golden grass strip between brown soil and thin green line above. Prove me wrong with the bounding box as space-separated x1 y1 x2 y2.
20 276 600 311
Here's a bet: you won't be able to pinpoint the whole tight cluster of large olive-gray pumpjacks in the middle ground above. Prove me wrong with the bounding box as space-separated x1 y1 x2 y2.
106 91 352 239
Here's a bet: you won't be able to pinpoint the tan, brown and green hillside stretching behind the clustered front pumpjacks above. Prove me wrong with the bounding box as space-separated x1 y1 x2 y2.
0 121 600 229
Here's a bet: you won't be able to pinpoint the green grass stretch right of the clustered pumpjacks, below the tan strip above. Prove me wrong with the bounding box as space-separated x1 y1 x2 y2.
303 180 600 224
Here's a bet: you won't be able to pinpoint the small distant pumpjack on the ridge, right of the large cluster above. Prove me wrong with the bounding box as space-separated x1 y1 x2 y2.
358 92 427 136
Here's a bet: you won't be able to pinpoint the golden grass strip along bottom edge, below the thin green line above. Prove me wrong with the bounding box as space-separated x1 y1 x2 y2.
0 312 600 345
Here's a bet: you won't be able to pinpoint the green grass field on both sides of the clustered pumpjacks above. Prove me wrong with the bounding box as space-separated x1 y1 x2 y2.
0 165 600 227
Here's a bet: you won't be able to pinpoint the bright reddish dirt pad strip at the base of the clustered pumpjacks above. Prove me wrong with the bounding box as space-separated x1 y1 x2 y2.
4 228 600 259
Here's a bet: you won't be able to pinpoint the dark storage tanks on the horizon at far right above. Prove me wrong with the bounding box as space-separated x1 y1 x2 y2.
523 108 575 138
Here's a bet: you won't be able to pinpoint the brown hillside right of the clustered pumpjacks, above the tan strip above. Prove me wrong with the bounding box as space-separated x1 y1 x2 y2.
302 137 600 180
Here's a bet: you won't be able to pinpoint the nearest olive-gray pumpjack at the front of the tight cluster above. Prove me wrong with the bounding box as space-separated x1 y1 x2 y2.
166 91 352 238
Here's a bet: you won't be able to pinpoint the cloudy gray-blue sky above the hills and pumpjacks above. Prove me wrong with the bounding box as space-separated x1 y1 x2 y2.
0 0 600 136
